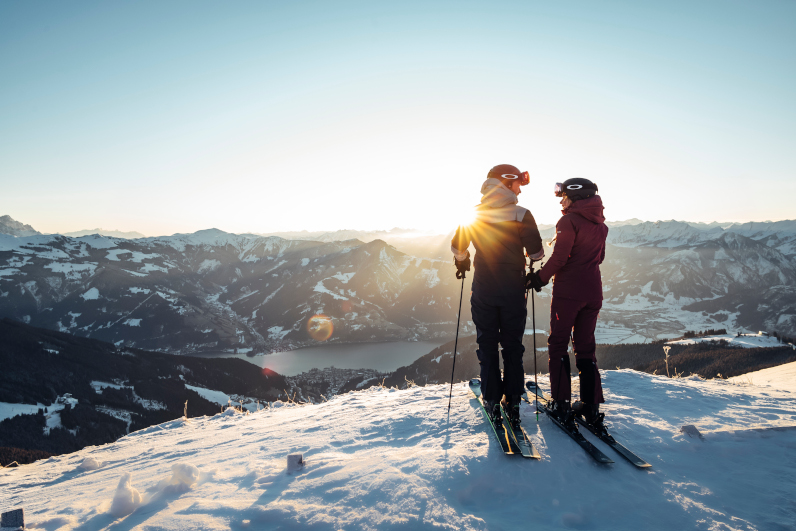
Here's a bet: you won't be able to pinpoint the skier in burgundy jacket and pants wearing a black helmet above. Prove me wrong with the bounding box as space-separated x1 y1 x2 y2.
526 178 608 430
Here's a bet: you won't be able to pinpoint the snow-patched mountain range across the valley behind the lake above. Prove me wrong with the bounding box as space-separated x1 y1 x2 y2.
0 217 796 353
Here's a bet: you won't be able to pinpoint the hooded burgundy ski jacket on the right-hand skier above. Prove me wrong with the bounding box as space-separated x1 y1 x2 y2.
539 195 608 302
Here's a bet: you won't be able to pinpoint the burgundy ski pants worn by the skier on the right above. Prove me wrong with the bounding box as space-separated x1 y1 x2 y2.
547 296 605 404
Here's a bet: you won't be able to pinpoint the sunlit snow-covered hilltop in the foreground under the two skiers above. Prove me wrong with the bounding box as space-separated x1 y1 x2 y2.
0 370 796 530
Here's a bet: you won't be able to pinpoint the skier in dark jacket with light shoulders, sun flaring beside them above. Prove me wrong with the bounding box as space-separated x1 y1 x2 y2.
451 164 544 426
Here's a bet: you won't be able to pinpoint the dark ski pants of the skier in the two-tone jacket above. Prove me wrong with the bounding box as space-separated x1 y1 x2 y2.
470 285 527 402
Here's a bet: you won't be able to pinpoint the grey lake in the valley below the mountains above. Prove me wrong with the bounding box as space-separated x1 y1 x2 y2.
192 341 446 376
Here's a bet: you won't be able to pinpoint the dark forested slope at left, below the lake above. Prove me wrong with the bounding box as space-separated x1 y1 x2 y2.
0 319 288 460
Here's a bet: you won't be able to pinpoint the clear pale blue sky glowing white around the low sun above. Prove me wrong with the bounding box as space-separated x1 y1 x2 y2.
0 0 796 235
